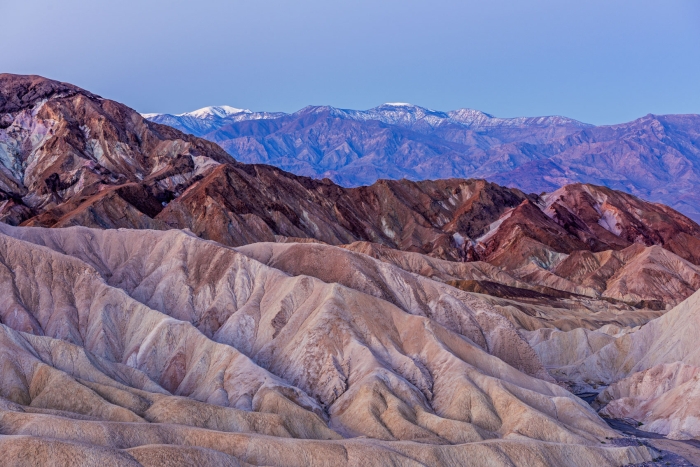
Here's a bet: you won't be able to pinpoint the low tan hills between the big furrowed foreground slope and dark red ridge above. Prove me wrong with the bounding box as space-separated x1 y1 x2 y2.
243 243 661 332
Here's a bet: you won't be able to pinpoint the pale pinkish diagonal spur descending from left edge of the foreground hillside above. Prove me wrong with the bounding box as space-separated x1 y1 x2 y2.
0 231 322 420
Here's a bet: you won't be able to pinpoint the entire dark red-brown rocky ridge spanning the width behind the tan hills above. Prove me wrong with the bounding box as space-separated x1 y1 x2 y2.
0 75 700 310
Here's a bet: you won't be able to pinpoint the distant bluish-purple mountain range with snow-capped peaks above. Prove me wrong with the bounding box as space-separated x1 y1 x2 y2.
146 103 700 221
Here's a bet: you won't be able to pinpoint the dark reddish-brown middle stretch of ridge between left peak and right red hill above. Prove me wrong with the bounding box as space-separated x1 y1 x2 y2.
156 165 525 260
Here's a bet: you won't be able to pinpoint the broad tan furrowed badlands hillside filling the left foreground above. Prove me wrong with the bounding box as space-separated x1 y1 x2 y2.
0 226 654 466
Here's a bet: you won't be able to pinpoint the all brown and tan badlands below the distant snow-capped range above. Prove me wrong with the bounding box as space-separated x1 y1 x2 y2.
0 75 700 467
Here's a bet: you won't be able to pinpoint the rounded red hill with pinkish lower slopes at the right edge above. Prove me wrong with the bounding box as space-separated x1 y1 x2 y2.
462 184 700 309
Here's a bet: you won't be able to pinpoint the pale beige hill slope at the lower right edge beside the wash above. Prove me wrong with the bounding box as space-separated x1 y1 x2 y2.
528 291 700 438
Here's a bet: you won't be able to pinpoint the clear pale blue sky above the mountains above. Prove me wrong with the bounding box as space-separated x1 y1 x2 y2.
0 0 700 124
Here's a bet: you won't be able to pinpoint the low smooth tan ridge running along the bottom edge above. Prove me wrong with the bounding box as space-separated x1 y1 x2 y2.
0 414 657 467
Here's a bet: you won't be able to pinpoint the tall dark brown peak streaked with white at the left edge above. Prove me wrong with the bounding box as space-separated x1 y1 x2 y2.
0 75 230 228
